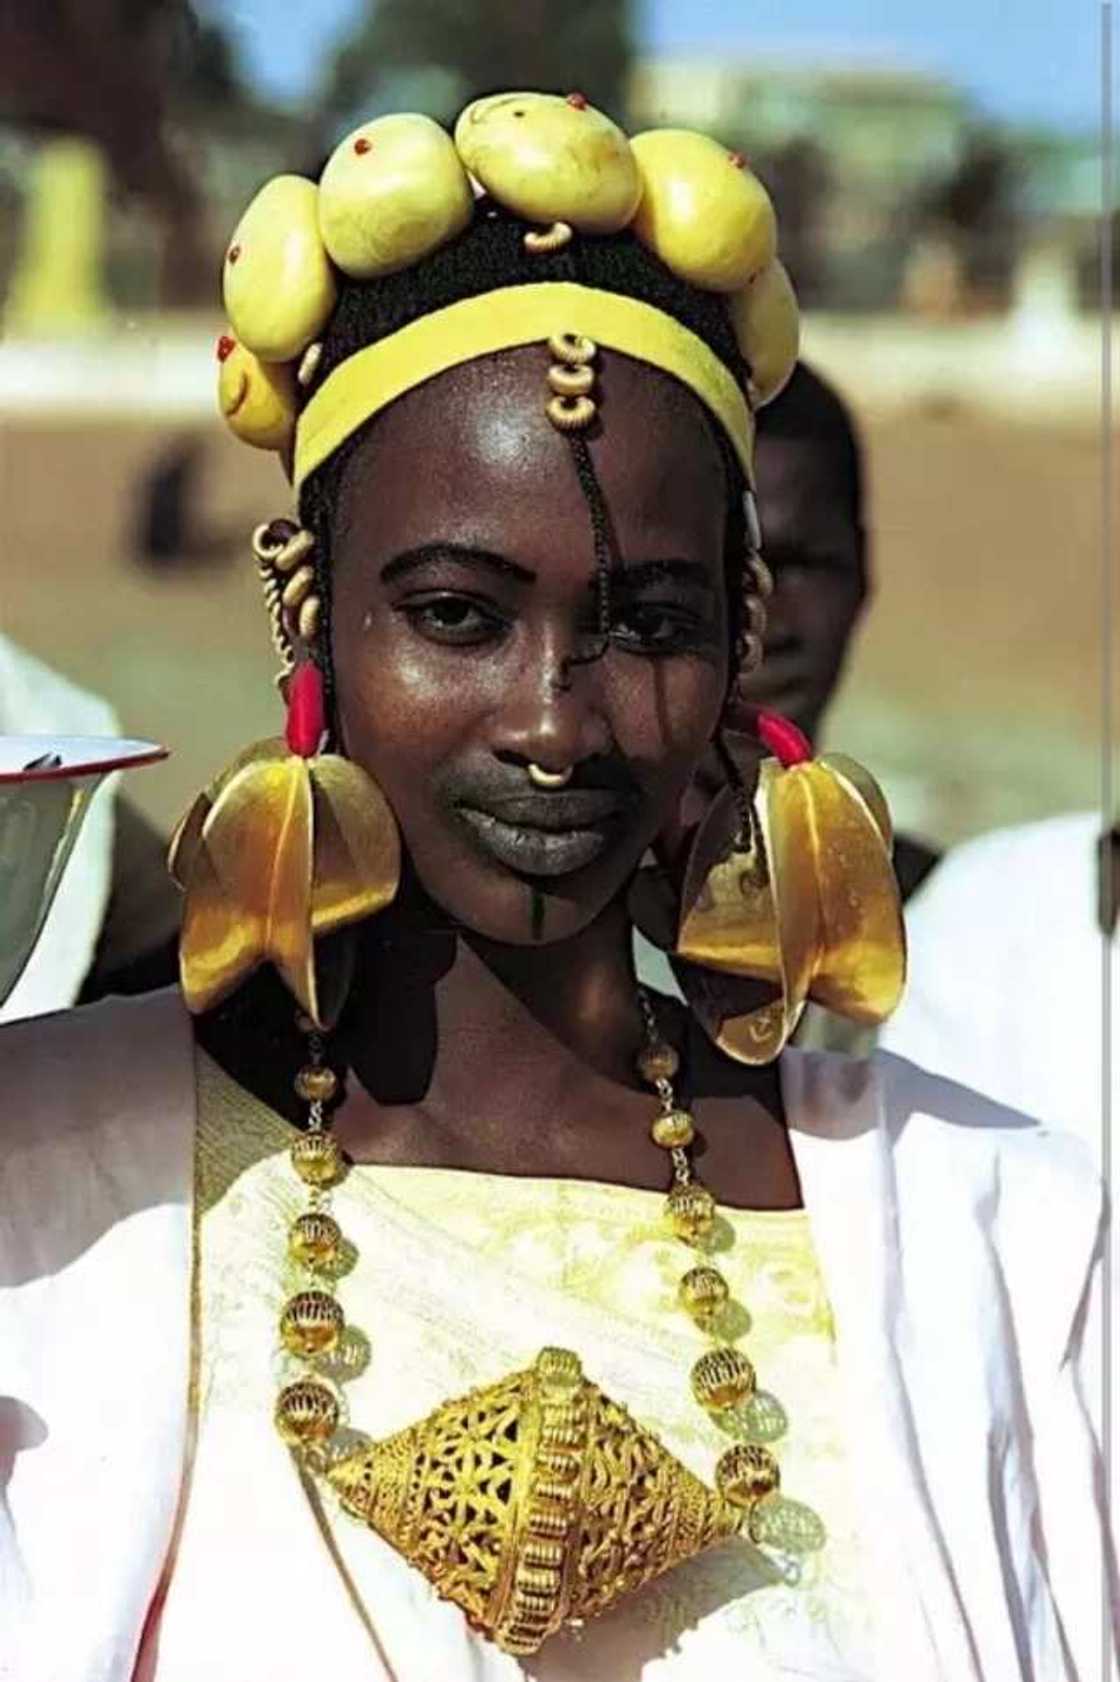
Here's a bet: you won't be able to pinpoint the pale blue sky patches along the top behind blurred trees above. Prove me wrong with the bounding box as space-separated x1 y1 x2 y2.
213 0 1120 131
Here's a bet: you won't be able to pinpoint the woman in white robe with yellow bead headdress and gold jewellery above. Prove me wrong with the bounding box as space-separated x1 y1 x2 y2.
2 94 1103 1682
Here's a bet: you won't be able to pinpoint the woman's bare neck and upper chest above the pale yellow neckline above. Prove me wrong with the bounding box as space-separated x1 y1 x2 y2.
198 905 799 1208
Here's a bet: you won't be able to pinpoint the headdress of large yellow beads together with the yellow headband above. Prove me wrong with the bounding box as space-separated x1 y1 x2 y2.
213 93 797 488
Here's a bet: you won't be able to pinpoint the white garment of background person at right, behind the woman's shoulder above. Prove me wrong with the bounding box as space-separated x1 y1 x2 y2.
880 812 1120 1161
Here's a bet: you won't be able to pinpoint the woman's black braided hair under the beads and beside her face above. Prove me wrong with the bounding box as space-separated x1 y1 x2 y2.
292 200 758 716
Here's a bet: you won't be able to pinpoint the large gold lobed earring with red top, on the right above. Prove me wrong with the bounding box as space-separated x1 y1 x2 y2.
632 711 906 1063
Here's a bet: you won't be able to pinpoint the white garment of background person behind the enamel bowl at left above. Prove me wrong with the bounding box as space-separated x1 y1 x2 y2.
0 634 121 1021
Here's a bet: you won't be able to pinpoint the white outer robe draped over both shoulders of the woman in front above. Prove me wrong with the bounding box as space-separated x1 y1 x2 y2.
0 992 1103 1682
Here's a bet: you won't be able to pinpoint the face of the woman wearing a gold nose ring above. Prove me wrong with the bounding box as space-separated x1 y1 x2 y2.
331 346 728 944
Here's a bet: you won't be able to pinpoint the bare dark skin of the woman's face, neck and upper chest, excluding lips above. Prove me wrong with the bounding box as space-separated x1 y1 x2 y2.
309 348 800 1208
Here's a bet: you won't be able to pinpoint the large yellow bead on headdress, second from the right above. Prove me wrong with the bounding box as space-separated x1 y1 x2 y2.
631 128 777 293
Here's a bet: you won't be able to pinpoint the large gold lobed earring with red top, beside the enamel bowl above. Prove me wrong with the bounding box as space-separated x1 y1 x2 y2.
168 659 400 1028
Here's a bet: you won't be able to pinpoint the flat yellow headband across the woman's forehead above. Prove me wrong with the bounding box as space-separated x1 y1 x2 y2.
293 281 755 491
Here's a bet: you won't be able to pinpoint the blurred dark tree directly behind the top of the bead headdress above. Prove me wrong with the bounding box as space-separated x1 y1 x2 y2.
323 0 631 138
